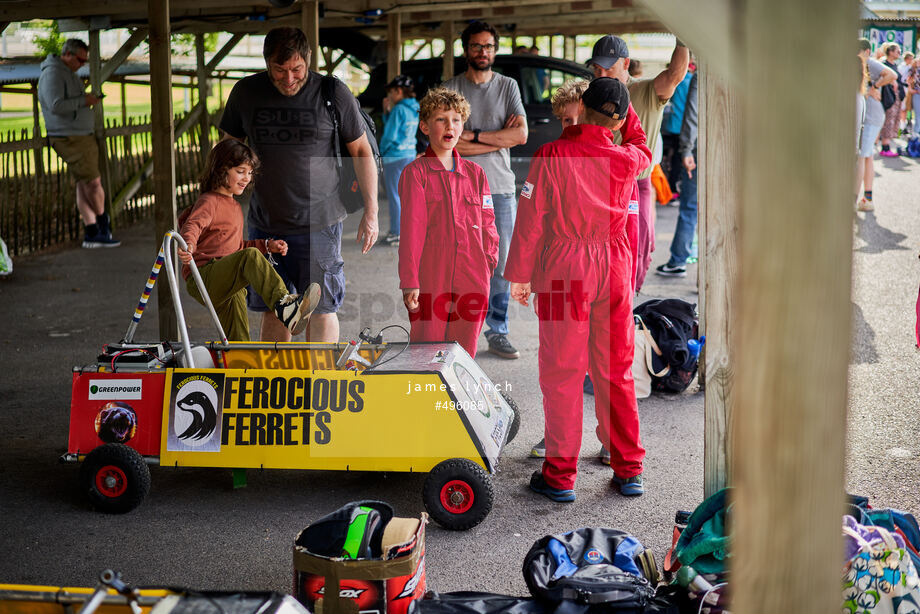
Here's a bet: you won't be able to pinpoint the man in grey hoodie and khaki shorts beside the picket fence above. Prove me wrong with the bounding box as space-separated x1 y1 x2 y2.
38 38 121 248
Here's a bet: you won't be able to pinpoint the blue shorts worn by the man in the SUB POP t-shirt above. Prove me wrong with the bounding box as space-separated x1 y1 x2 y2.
246 222 345 313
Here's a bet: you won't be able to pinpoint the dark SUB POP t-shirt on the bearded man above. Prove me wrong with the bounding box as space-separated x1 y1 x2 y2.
220 71 365 234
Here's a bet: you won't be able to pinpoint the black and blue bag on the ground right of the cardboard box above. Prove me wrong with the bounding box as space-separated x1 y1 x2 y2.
523 528 677 614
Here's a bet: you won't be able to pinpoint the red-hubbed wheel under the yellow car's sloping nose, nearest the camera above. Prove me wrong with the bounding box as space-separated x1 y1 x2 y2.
422 458 494 531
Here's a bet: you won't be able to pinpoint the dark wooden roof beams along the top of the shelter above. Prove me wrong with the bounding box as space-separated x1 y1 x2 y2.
0 0 667 38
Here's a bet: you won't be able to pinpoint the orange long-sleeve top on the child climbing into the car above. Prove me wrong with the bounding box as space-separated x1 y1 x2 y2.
179 192 268 279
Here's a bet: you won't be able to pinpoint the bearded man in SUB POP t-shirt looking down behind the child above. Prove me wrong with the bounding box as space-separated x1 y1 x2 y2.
220 28 377 343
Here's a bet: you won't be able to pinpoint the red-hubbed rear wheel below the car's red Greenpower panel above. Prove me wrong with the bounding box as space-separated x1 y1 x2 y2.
80 443 150 514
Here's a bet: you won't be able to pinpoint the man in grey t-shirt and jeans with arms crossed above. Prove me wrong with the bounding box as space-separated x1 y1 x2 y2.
444 21 527 358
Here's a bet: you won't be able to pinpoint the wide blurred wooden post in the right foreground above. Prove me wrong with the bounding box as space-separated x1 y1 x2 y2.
719 0 858 614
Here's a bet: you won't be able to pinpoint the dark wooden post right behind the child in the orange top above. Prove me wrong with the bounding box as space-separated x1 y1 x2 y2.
147 0 178 339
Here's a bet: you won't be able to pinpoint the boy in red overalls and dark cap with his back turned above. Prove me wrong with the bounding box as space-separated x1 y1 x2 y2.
505 78 652 502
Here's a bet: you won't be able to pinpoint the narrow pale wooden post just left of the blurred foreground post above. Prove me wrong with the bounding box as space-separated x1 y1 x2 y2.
696 62 741 497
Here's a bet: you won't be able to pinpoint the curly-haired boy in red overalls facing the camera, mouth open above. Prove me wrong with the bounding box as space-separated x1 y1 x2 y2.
399 88 498 357
